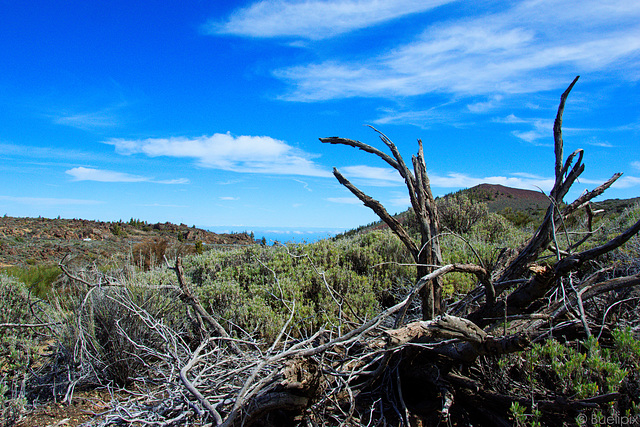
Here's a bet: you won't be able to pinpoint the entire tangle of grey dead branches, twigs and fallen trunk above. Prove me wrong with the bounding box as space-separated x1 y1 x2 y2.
21 78 640 426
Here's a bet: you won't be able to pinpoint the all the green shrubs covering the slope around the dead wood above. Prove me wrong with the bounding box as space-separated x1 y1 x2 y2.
0 194 640 426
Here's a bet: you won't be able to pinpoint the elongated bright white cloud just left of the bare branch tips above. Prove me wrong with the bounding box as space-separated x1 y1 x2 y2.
105 133 331 177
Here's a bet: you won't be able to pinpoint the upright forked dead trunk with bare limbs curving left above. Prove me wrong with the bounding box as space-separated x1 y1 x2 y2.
320 127 442 320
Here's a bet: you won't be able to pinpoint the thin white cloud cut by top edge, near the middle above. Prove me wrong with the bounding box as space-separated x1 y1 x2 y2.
204 0 455 40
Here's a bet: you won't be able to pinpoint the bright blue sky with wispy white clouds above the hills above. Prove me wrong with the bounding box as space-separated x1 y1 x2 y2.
0 0 640 234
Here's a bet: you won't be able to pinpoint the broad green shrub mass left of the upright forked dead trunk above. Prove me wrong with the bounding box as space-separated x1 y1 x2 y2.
184 230 415 341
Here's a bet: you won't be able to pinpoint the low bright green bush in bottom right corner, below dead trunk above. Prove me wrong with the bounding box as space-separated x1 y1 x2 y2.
496 328 640 426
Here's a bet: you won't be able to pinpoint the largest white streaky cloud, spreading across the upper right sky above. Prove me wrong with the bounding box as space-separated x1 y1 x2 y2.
274 0 640 102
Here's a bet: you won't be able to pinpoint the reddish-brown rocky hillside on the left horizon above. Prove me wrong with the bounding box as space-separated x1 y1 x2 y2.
0 216 255 267
